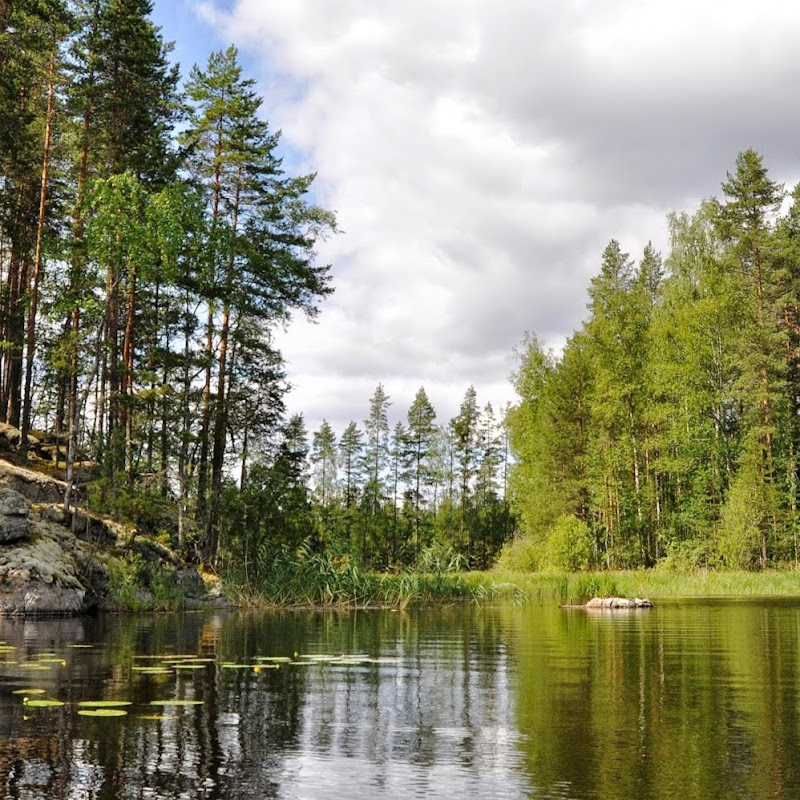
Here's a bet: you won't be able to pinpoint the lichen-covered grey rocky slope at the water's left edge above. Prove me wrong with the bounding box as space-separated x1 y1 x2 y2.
0 460 225 616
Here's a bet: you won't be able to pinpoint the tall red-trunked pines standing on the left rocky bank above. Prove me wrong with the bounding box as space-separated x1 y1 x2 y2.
0 0 335 564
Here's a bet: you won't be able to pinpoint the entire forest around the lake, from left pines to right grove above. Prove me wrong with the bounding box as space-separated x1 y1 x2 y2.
6 0 800 584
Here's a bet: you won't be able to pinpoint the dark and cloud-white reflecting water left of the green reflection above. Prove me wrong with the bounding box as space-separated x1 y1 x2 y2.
0 610 523 800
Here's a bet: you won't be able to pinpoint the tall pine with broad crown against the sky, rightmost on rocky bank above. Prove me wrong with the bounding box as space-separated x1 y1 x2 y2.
182 47 334 560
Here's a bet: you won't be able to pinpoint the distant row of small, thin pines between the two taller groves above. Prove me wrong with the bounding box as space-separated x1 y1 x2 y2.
223 384 514 583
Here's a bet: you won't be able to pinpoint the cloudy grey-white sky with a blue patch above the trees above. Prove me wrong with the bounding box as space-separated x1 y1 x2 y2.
153 0 800 432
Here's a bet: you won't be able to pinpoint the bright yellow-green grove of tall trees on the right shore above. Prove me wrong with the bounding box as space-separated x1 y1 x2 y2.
506 150 800 569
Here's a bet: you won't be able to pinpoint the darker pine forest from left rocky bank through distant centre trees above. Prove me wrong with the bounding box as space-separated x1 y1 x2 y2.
0 0 513 582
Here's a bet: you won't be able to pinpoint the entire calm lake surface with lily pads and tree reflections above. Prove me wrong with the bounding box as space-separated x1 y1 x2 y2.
0 601 800 800
